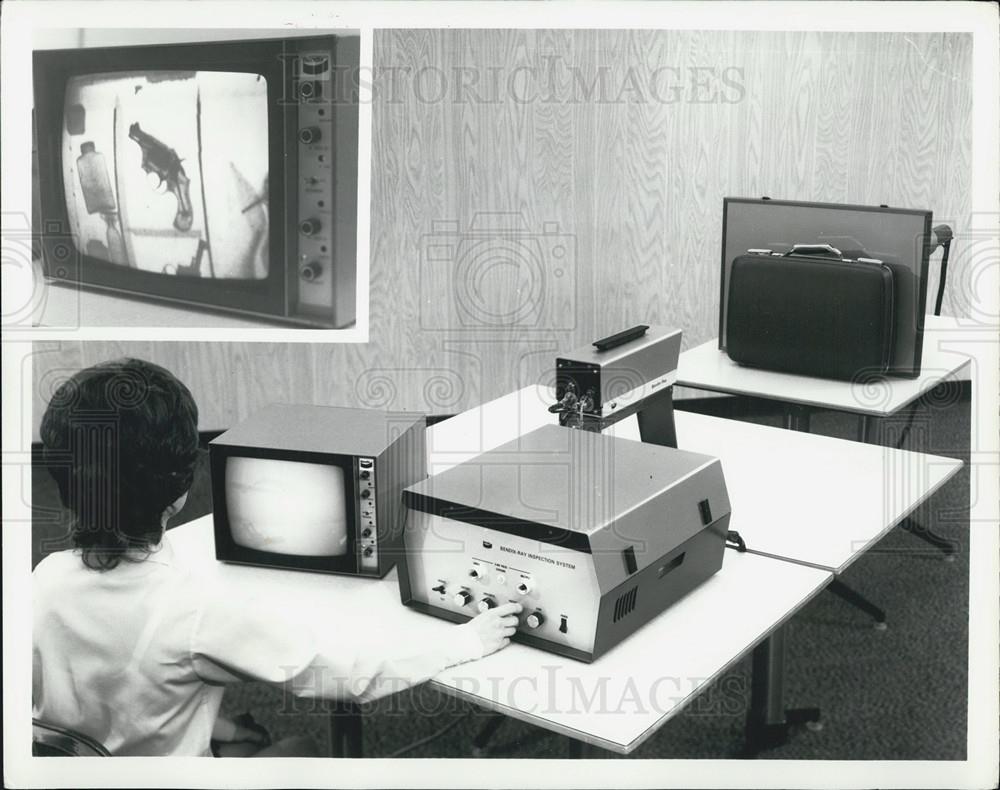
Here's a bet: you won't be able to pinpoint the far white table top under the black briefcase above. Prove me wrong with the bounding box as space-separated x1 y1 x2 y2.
677 315 971 417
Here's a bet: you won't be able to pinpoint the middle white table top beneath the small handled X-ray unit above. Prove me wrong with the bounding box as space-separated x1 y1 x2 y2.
442 386 962 573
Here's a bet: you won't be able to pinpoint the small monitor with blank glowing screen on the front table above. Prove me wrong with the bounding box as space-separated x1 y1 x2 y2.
209 404 427 577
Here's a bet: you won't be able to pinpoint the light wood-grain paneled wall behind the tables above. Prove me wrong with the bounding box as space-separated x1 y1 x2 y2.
29 30 972 436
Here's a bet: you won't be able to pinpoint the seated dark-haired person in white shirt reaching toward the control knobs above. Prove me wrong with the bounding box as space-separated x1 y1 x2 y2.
32 359 520 757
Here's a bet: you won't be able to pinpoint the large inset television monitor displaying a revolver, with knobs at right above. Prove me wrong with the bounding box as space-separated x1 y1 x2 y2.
34 35 360 328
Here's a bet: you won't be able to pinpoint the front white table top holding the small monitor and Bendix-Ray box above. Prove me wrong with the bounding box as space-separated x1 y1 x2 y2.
167 516 832 754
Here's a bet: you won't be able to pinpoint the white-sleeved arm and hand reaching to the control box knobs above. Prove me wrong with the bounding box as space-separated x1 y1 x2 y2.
190 592 521 701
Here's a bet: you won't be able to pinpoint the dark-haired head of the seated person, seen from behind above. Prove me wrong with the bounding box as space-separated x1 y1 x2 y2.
41 359 198 570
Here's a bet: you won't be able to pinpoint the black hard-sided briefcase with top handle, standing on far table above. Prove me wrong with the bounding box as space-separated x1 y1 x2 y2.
726 245 894 380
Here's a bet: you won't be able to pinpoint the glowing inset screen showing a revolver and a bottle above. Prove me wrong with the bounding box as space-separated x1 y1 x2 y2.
63 71 270 280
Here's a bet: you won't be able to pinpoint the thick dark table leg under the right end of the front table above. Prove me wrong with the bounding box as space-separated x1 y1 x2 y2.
744 626 820 757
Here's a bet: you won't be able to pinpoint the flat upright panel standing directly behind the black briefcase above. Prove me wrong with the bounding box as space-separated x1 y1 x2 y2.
719 198 932 378
